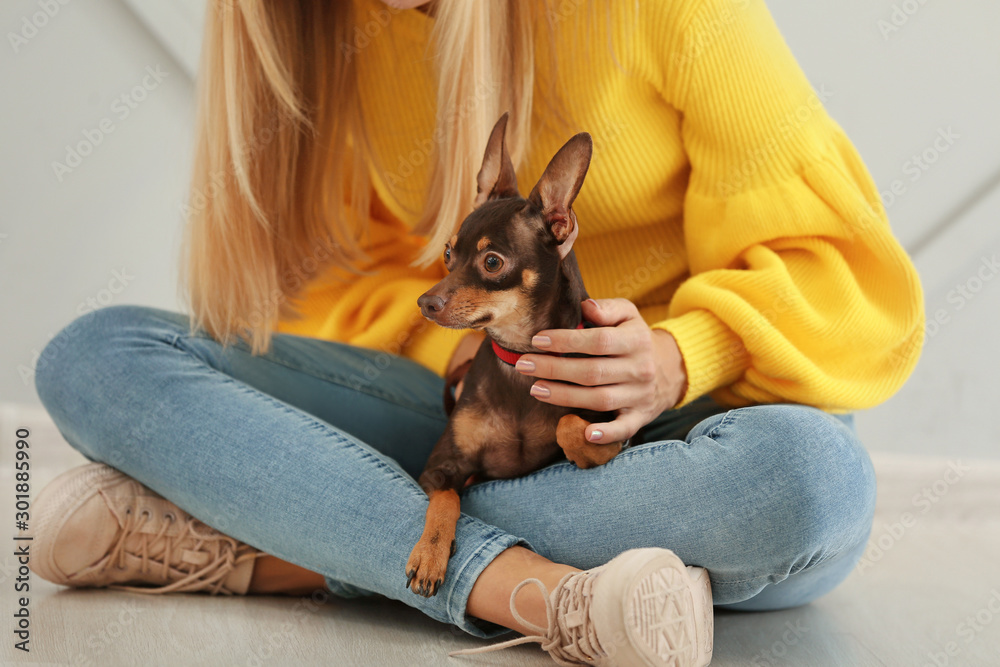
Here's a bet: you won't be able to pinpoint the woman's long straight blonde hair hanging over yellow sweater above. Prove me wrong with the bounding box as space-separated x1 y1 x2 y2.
180 0 612 354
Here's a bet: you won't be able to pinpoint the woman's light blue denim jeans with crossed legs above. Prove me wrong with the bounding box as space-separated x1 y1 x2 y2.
35 305 875 637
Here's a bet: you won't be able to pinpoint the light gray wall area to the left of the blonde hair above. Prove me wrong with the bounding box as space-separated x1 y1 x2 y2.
0 0 194 402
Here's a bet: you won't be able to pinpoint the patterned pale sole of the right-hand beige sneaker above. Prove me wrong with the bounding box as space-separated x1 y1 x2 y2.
595 549 715 667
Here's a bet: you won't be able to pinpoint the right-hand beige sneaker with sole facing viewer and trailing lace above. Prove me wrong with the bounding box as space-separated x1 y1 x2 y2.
450 548 714 667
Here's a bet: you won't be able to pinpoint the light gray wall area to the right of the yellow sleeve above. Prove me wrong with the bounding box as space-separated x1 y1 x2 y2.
768 0 1000 458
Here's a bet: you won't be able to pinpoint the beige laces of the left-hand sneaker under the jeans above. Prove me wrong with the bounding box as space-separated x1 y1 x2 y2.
101 510 264 595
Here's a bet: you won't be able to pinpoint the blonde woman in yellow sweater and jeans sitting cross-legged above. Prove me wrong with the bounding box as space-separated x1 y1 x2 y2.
32 0 923 664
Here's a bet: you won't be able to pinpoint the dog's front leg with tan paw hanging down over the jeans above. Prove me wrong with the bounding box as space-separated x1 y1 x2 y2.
406 423 475 597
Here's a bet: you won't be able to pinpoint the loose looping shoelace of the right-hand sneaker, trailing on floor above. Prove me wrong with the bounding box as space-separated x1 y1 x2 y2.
448 572 607 665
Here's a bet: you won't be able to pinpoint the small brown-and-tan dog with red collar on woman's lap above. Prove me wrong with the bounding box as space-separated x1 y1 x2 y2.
406 113 622 597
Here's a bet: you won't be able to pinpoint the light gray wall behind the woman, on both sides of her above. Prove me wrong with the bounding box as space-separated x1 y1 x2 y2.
0 0 1000 456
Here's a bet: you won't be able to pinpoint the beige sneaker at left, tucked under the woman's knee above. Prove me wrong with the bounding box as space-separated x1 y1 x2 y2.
30 463 264 595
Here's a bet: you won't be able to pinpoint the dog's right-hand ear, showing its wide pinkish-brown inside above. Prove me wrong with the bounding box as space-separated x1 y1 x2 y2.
528 132 594 258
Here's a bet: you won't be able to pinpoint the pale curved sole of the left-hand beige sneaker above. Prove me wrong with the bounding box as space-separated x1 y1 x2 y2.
31 463 126 586
